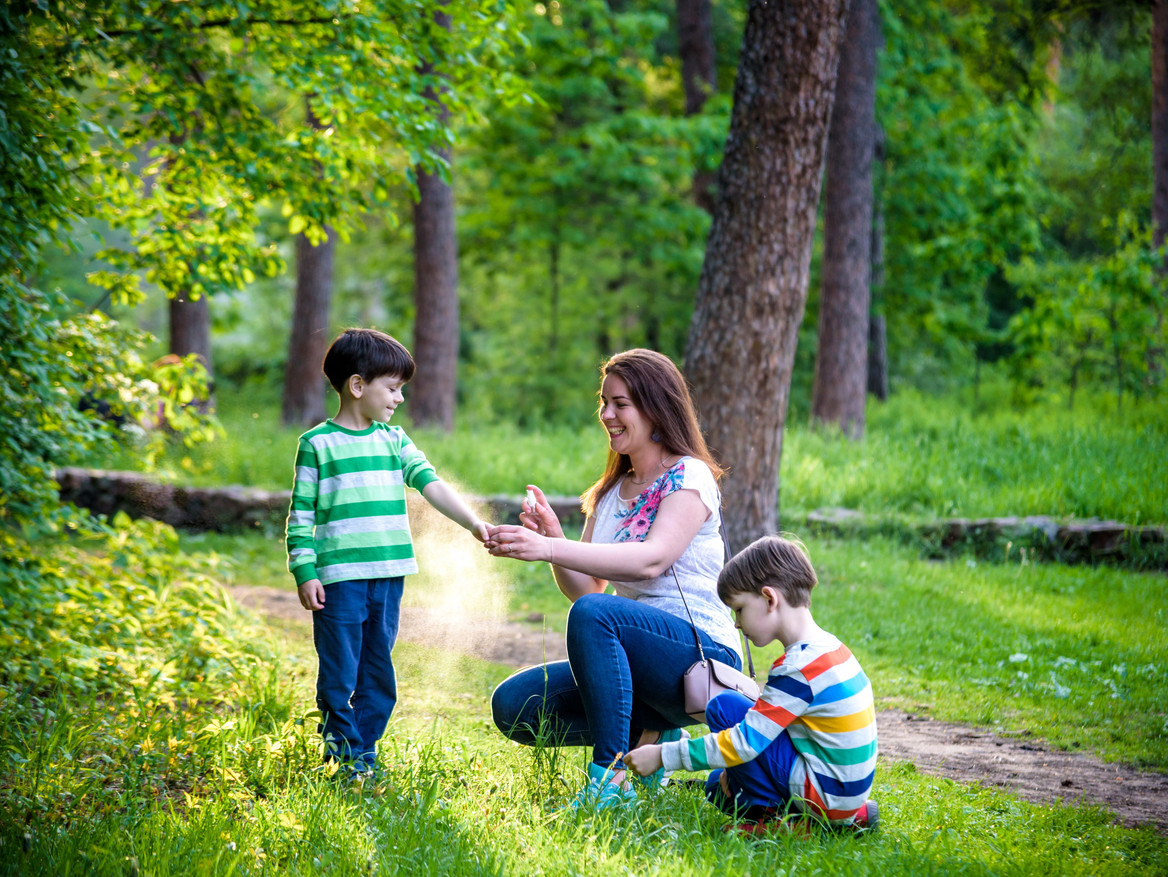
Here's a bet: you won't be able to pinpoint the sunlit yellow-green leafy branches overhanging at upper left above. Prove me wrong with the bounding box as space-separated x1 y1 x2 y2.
5 0 520 301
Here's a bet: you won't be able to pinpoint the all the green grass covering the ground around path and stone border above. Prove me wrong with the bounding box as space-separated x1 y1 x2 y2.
15 383 1168 876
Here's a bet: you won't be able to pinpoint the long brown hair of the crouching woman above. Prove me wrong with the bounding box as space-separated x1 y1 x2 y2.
580 347 722 516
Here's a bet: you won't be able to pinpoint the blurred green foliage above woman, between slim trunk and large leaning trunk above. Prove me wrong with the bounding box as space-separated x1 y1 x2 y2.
459 0 729 425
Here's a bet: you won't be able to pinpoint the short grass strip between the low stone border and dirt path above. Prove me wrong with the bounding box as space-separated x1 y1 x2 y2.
181 530 1168 772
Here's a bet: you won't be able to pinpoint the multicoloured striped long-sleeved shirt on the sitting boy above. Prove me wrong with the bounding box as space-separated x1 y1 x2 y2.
661 634 876 822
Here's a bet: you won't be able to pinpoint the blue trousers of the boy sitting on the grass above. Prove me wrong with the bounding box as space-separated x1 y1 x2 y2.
705 691 799 819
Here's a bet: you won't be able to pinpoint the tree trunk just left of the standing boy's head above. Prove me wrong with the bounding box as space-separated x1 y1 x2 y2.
280 98 336 426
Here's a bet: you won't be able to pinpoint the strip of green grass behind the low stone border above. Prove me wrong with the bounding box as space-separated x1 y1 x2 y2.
88 378 1168 524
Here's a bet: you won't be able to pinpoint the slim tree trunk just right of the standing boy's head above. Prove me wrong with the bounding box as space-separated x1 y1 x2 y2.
409 6 459 432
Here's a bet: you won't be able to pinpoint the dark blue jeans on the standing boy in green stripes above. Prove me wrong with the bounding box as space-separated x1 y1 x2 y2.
312 576 403 770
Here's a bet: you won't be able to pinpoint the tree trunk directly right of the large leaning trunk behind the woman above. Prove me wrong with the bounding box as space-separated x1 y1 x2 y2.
811 0 880 438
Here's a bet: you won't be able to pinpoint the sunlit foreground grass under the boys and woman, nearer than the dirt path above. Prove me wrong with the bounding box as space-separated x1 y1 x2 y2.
0 627 1168 876
